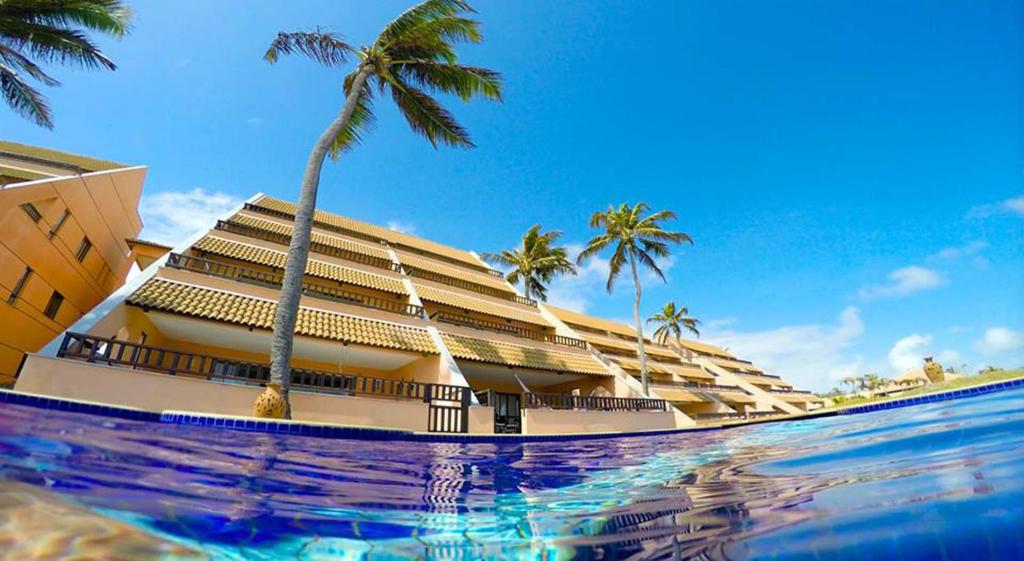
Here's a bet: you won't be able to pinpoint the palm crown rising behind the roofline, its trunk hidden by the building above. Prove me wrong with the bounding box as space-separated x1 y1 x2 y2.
483 224 575 301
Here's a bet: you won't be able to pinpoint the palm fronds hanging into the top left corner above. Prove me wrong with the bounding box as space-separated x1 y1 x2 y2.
0 0 131 129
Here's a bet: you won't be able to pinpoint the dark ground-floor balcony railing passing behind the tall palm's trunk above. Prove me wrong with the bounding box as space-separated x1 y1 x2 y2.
57 333 452 401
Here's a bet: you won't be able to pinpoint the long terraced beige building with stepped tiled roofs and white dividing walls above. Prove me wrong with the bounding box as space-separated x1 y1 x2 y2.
15 195 819 434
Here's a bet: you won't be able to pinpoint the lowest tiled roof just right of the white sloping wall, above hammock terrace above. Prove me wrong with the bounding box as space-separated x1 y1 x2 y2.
441 333 611 376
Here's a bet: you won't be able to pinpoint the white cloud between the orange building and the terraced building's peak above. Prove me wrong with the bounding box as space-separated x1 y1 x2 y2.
138 188 242 246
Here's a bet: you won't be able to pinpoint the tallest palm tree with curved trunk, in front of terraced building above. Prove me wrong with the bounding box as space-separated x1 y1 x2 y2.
264 0 502 418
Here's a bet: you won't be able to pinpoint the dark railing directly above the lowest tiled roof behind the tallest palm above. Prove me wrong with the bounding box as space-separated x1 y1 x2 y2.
167 253 423 317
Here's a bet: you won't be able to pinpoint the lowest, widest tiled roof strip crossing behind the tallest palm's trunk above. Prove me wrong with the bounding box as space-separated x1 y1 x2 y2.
128 278 437 354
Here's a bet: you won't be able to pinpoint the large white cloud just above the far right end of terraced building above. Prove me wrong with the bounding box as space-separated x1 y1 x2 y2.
705 306 864 390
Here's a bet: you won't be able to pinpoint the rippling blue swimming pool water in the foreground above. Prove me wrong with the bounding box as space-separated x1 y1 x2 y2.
0 390 1024 561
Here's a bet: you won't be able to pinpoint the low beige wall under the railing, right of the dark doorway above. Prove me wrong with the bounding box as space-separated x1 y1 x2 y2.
522 409 676 434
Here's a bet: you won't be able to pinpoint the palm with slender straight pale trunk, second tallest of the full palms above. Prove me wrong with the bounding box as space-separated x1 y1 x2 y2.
577 203 693 395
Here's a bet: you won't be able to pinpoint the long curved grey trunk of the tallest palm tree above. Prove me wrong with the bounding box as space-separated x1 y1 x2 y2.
270 69 370 419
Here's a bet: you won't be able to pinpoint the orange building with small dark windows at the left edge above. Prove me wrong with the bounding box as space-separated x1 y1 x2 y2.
0 141 155 385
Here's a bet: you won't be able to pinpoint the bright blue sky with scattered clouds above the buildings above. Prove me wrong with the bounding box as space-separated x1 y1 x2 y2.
0 0 1024 389
